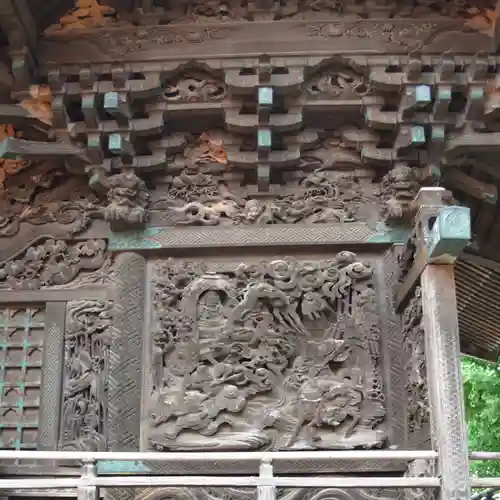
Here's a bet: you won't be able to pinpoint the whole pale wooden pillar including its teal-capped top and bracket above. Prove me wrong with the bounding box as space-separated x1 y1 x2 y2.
396 188 471 500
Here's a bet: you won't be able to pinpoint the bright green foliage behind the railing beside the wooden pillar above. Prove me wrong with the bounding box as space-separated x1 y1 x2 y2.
462 358 500 477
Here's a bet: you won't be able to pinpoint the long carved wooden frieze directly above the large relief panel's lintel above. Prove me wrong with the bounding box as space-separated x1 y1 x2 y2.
151 168 379 226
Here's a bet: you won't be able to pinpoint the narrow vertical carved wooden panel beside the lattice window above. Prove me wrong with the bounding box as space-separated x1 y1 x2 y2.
60 301 111 451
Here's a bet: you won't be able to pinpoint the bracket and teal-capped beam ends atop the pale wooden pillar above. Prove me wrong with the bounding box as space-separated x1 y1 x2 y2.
395 188 471 310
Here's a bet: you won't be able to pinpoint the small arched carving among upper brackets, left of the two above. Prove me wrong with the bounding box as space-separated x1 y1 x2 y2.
164 73 227 102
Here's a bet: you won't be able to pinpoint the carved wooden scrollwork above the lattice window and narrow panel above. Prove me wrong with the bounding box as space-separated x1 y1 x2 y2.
0 239 106 290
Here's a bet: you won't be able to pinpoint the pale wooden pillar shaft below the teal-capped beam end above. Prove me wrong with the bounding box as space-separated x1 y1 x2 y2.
421 264 471 500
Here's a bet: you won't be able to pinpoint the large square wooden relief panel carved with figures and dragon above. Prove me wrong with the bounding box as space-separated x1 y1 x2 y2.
148 252 386 450
